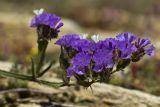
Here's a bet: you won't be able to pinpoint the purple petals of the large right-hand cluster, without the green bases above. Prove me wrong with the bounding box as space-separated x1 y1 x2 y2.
56 32 155 78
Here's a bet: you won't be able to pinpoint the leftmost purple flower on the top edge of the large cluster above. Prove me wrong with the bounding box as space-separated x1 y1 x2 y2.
55 34 80 47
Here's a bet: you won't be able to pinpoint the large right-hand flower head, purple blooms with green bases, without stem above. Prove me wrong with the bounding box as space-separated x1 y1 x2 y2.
56 32 155 87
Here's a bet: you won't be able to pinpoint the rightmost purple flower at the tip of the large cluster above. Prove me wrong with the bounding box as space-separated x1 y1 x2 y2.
135 38 155 56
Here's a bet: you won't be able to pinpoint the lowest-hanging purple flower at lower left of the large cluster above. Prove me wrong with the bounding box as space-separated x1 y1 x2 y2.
67 52 91 77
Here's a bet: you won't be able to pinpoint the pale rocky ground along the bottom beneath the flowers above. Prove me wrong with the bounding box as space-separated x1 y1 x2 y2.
0 62 160 107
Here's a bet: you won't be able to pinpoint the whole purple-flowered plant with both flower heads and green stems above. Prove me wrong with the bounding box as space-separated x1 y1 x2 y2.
0 9 155 87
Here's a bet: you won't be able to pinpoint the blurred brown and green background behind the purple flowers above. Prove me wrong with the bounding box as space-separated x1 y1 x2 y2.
0 0 160 106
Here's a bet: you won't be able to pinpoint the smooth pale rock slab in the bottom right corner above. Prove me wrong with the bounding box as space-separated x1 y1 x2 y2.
90 84 160 107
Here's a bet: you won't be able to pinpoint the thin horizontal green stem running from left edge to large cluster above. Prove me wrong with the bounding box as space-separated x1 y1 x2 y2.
0 70 65 88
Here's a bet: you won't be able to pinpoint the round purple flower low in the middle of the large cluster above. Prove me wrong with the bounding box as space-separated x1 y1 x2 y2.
93 49 114 72
